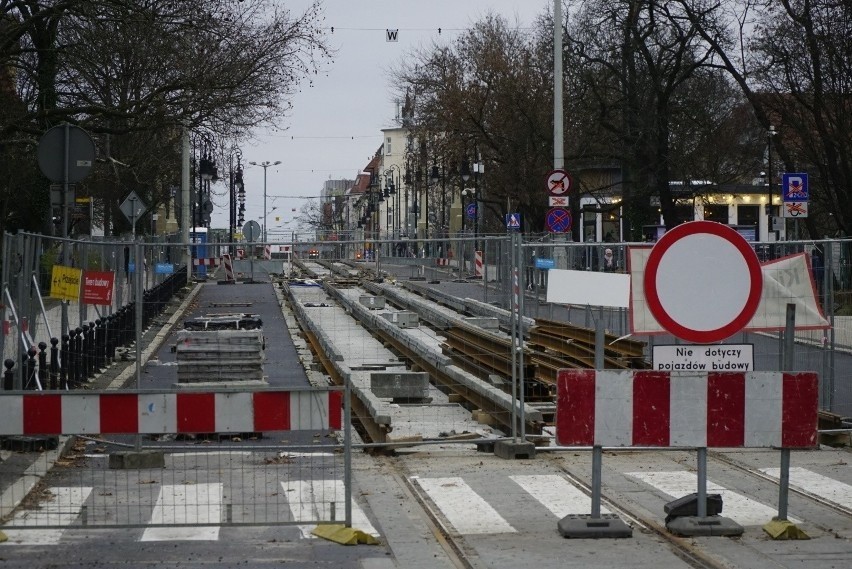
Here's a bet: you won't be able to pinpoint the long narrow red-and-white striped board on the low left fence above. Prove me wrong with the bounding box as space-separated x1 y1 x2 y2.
0 390 343 435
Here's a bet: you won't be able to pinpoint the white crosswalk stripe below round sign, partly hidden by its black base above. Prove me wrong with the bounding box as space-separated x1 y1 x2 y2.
625 470 795 526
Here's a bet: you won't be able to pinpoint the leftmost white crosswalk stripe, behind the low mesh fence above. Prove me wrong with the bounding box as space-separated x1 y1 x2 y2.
3 486 92 545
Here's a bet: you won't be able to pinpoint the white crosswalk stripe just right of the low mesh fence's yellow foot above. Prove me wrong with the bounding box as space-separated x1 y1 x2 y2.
414 477 517 535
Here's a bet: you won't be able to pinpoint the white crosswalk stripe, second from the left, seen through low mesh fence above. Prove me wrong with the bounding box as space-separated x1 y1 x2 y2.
140 483 223 541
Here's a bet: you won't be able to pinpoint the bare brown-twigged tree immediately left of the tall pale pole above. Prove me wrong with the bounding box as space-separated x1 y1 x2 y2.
394 15 553 231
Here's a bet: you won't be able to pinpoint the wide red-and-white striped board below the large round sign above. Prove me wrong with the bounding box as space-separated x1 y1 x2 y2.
556 370 819 448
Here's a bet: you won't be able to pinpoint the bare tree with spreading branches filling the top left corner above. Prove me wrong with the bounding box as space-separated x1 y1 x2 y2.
0 0 330 233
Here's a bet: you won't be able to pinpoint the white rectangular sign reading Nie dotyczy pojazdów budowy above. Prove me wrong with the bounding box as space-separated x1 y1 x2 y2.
652 344 754 371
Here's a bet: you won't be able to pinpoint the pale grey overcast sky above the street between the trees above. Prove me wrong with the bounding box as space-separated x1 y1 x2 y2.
212 0 553 232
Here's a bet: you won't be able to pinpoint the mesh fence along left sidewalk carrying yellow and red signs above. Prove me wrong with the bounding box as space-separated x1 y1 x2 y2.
0 234 187 389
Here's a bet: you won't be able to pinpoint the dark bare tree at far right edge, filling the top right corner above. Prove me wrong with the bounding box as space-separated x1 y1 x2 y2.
679 0 852 238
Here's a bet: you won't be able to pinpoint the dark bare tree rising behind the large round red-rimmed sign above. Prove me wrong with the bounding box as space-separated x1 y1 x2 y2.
568 0 743 239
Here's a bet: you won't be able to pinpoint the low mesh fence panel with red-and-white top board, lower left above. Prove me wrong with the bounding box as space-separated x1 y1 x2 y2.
0 388 356 532
